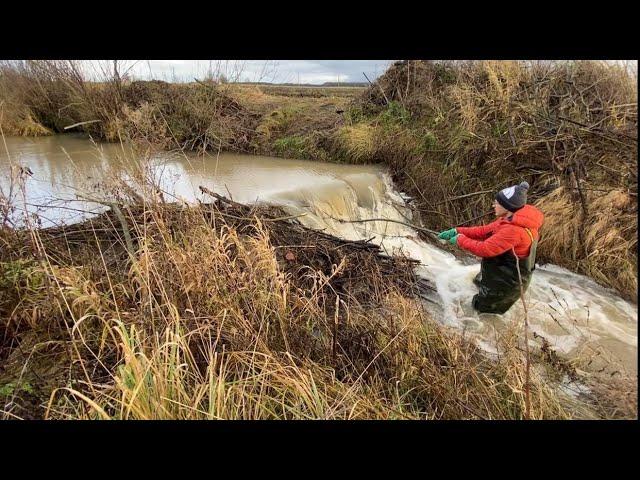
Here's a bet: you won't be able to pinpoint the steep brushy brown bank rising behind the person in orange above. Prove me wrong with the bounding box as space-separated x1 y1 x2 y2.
332 61 638 301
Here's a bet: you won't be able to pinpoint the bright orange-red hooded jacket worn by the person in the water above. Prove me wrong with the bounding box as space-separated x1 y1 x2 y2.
456 205 544 258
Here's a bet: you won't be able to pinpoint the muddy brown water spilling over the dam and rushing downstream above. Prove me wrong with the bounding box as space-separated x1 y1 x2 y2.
0 135 638 374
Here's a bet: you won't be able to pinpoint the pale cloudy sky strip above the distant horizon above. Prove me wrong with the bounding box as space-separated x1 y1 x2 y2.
85 60 391 84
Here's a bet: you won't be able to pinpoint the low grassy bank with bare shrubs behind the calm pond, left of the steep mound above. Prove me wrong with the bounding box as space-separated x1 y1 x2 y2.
0 60 362 156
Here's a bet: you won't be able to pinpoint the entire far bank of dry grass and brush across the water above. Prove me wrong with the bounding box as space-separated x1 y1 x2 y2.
0 61 637 304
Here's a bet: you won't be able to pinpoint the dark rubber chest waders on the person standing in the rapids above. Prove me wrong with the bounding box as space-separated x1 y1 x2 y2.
471 228 538 314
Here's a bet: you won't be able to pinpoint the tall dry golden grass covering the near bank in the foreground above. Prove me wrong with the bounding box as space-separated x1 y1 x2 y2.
0 159 604 419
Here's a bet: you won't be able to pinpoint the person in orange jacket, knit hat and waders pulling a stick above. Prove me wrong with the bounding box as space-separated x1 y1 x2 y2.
438 182 544 314
